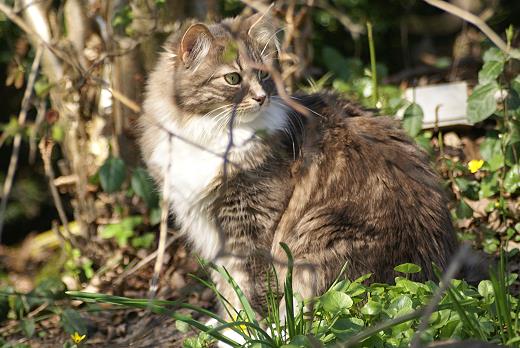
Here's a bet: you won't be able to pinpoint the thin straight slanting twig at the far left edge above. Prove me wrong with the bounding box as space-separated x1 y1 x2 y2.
0 45 43 241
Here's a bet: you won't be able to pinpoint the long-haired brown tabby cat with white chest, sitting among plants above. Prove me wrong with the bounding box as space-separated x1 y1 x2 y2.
140 15 457 320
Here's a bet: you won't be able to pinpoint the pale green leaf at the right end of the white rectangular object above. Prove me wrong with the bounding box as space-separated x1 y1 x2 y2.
467 82 498 124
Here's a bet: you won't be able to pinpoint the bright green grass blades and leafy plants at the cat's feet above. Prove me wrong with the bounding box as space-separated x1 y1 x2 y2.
67 246 520 347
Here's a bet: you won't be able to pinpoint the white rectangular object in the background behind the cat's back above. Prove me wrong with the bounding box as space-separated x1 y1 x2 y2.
399 82 470 129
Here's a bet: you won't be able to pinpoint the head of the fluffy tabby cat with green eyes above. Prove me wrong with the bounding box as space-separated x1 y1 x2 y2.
157 14 277 122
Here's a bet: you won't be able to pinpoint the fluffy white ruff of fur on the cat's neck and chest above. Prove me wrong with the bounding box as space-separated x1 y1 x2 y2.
149 103 288 260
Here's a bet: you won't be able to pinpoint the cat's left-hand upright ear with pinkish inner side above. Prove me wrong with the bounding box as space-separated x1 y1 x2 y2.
179 23 213 65
